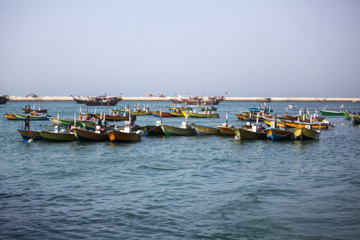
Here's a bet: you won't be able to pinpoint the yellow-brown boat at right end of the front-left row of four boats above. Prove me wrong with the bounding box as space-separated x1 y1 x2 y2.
107 116 141 143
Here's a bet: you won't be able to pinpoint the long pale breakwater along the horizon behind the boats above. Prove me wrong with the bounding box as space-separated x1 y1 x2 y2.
6 96 360 102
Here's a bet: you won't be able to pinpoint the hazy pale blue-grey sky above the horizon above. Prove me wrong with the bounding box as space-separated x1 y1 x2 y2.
0 0 360 97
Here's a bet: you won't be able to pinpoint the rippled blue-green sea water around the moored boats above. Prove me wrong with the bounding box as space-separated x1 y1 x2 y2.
0 101 360 240
